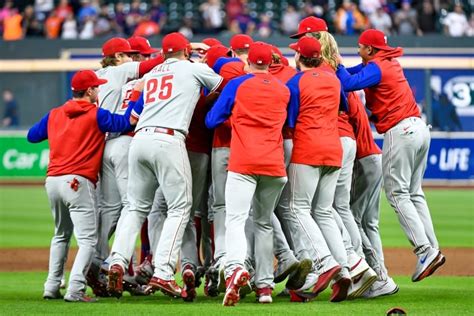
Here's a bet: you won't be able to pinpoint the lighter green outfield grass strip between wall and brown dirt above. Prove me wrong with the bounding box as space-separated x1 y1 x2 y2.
0 186 474 248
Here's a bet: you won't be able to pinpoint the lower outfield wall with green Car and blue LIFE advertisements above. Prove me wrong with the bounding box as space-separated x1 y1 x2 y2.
0 131 474 186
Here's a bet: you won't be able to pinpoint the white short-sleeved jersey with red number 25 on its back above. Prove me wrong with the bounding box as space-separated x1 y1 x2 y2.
136 58 222 134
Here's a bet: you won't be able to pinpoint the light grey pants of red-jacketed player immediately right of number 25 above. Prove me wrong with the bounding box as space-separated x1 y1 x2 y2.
225 171 287 288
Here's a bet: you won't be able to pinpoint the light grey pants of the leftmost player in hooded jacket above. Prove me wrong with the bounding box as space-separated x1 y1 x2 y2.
44 175 97 294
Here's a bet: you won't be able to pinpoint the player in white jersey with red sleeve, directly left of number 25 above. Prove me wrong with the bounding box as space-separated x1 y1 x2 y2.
88 37 163 296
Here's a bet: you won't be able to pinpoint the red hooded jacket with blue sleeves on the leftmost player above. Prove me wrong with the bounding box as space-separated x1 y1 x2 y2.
28 100 132 183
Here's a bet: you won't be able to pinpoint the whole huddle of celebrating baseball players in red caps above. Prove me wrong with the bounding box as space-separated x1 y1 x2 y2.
28 17 446 306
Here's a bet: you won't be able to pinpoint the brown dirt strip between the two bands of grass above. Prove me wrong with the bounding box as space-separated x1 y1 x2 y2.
0 248 474 276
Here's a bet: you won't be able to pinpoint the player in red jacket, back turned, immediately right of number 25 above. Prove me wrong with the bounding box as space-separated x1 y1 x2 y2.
206 42 289 306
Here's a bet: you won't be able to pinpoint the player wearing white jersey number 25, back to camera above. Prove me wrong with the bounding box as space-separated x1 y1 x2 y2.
109 33 222 297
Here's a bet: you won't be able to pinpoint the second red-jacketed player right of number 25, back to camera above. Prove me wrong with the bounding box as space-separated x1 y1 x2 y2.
287 37 351 302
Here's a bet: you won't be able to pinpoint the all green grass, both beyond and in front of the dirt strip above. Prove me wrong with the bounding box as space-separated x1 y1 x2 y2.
0 187 474 315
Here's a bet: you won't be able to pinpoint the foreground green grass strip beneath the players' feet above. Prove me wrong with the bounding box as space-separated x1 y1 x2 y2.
0 272 474 316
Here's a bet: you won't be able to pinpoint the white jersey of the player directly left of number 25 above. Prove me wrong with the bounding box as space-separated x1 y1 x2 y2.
95 62 140 113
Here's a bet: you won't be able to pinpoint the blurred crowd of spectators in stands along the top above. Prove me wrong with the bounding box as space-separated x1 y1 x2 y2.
0 0 474 40
